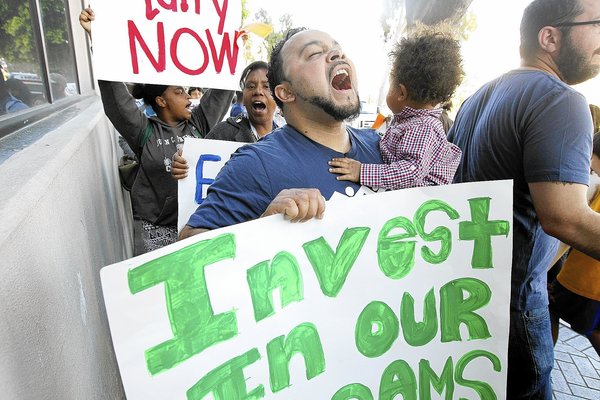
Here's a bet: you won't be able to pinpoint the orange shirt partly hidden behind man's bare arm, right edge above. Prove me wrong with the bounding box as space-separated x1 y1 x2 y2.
557 190 600 301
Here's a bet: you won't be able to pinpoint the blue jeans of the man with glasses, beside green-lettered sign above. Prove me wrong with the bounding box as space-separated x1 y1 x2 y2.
506 307 554 400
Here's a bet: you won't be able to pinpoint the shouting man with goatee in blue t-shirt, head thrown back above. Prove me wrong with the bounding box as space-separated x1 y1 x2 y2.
180 28 381 238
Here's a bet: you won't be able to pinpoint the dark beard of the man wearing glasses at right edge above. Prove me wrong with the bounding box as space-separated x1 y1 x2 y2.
556 33 600 85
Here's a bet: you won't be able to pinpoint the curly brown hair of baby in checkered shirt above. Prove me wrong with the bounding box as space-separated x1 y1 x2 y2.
390 25 464 104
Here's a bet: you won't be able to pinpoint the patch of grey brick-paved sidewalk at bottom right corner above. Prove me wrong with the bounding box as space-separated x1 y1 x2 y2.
552 321 600 400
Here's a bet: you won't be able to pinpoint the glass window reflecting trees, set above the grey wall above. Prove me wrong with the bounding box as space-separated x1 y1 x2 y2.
0 0 79 115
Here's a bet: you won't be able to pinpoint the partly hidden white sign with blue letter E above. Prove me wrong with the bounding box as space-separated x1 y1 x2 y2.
177 138 247 231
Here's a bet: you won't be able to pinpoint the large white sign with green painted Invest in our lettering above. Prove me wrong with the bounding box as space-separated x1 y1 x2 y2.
101 181 512 400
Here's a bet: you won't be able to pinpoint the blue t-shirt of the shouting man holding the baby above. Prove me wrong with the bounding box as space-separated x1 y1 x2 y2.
187 125 382 229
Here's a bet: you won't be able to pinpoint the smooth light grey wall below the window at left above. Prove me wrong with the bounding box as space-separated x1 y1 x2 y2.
0 97 131 399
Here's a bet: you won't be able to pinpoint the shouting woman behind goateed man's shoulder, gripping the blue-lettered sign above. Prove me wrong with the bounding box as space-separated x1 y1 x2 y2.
171 61 277 179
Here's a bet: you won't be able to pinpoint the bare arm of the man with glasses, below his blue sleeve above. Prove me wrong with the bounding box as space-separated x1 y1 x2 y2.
529 182 600 260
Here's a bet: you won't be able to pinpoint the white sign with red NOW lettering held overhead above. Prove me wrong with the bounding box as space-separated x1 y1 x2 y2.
92 0 244 90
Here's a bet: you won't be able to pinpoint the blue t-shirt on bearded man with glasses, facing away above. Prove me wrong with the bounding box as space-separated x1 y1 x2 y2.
448 70 592 310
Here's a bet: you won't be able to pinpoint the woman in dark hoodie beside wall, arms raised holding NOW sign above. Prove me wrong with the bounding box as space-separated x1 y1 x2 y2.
79 8 232 255
